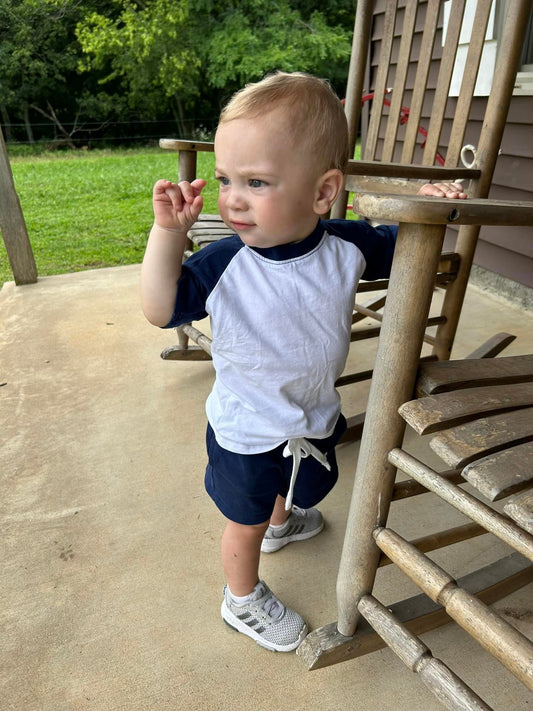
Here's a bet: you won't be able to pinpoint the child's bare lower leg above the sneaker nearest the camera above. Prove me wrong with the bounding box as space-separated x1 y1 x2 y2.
221 521 268 597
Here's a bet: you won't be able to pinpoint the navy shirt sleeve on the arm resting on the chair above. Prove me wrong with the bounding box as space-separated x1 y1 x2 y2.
326 220 398 280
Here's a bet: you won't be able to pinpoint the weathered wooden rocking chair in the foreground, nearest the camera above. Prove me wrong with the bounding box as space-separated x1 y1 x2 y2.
298 0 533 709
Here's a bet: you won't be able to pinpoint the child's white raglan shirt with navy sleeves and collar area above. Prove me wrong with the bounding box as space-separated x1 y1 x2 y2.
166 220 397 454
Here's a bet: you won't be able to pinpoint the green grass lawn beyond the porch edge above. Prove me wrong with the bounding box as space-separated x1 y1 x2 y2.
0 148 218 284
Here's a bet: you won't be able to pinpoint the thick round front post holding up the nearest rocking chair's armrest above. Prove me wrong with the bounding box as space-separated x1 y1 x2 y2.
337 224 444 637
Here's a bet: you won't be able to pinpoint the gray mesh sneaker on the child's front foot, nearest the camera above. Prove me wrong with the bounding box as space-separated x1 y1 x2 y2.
220 580 307 652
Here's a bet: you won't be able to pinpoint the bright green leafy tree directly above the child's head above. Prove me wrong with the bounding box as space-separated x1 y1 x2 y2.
77 0 351 135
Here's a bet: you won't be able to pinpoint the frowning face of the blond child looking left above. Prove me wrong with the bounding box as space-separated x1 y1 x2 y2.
215 111 321 247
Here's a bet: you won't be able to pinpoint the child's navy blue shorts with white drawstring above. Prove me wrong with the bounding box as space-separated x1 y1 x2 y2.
205 415 346 526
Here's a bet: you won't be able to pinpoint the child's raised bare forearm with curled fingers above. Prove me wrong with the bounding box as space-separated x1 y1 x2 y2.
141 180 206 326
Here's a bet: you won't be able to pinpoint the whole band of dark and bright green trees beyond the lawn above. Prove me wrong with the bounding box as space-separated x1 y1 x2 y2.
0 0 355 145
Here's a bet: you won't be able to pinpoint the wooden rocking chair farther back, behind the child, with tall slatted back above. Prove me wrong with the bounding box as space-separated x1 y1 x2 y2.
160 0 522 441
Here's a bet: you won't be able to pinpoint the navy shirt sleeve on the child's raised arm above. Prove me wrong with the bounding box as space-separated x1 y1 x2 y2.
163 235 244 328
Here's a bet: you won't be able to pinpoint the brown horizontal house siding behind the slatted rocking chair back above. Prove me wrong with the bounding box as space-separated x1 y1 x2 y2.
361 0 533 288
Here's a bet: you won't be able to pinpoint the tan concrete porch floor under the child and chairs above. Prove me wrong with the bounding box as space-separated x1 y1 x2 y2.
0 265 533 711
